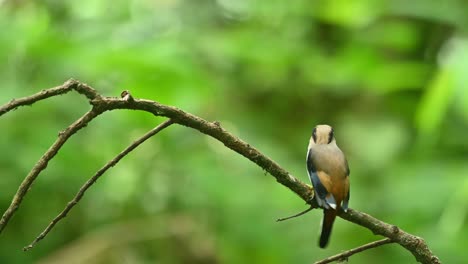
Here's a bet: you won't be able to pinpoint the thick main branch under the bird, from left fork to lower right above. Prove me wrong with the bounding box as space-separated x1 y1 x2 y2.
93 98 440 264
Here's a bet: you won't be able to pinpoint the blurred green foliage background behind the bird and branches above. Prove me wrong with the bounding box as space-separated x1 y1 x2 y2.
0 0 468 263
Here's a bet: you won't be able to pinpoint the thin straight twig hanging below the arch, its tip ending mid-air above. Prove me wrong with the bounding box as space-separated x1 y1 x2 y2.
23 119 173 251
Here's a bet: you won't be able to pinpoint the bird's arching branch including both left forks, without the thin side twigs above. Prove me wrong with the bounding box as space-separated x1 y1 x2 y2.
0 80 440 263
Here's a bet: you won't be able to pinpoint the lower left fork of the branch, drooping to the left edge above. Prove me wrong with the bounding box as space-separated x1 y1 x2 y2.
0 108 102 233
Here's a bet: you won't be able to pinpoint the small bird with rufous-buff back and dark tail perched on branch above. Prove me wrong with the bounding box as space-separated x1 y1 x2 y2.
307 125 349 248
